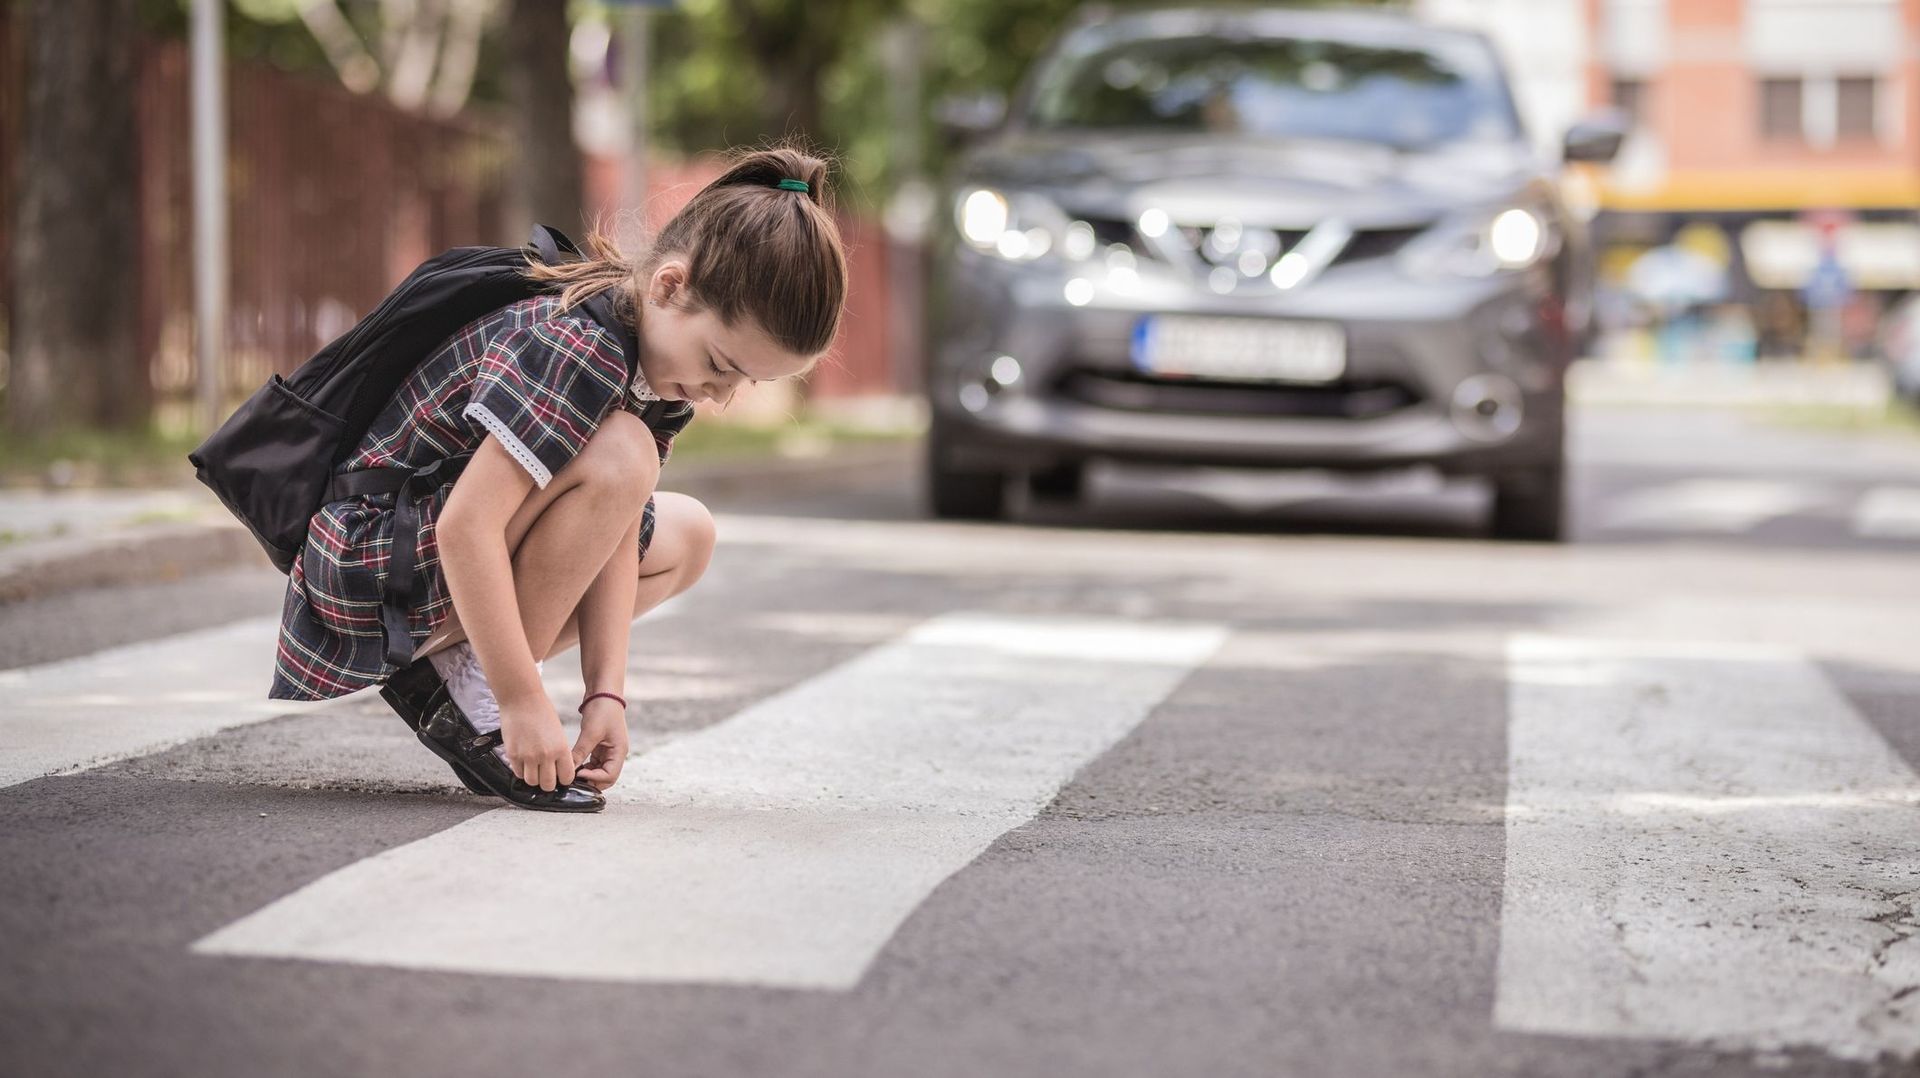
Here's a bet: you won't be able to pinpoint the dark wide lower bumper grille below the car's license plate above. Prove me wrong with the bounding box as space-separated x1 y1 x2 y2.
1054 367 1421 419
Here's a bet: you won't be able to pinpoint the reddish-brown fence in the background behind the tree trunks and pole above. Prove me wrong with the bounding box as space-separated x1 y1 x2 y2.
0 19 914 416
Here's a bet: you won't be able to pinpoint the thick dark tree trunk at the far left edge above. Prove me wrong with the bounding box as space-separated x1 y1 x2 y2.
6 0 154 434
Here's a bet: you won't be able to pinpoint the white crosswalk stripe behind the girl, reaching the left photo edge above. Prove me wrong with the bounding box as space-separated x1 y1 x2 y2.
0 617 326 786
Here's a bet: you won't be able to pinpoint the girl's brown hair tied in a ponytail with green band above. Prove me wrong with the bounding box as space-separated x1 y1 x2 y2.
526 142 847 365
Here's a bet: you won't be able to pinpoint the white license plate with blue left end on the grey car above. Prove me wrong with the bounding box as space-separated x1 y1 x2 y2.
1133 315 1346 382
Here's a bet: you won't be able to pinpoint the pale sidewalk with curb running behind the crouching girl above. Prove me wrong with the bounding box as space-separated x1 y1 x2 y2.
0 438 918 607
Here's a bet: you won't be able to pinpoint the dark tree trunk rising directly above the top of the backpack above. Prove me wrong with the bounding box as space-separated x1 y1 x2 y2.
507 0 584 242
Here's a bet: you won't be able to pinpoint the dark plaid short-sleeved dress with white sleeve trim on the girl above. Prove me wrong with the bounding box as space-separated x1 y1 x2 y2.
267 296 693 699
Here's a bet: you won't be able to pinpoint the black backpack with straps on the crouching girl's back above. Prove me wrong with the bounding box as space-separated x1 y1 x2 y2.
186 225 678 667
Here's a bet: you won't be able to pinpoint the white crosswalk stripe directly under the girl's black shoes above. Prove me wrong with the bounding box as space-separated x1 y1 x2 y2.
194 615 1227 990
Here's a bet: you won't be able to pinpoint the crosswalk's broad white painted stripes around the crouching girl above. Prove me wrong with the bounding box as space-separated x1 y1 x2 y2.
0 580 1920 1059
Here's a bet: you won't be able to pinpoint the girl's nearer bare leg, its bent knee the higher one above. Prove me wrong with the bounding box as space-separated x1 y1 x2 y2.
415 411 660 659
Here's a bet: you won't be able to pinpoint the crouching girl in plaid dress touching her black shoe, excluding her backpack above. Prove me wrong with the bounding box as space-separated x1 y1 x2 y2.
269 146 847 811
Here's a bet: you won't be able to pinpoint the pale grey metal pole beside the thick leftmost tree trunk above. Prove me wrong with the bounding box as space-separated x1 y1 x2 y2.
192 0 227 430
